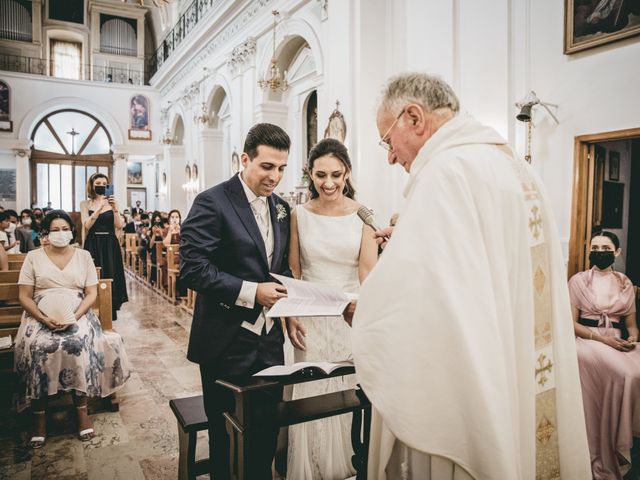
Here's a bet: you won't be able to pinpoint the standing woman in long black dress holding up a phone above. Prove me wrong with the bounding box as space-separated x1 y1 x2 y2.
80 173 129 320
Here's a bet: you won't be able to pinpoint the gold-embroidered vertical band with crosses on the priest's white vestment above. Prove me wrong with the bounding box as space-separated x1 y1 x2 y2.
499 145 560 480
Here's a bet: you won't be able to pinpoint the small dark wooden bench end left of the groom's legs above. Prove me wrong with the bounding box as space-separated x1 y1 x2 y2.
169 395 209 480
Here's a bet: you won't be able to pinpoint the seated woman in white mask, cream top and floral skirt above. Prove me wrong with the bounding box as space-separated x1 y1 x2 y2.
15 210 131 448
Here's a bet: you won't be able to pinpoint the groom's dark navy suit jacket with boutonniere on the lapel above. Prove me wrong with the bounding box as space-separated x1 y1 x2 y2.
180 175 291 366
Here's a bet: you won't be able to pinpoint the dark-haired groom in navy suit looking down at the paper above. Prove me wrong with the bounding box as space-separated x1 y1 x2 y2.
180 123 291 480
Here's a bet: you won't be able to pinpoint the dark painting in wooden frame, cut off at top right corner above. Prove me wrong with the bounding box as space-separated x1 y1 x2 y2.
564 0 640 54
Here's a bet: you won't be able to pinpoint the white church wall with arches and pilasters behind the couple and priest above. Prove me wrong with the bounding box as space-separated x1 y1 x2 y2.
145 0 640 242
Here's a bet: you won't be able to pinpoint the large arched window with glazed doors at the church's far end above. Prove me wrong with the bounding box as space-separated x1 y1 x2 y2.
31 110 113 212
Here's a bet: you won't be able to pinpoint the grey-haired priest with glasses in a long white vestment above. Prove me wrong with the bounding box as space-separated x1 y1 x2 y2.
352 74 591 480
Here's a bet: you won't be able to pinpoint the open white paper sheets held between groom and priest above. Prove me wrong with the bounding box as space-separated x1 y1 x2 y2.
266 273 358 317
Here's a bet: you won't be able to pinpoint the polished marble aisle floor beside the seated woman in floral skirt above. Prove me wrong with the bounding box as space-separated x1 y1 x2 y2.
0 279 208 480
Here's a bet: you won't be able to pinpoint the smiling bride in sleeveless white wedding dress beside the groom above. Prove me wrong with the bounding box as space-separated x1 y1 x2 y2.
287 139 377 480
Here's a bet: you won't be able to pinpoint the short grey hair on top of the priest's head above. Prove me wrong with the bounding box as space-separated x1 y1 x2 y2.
379 72 460 115
